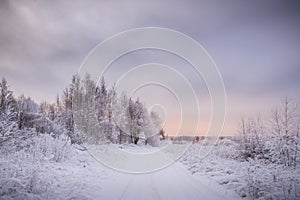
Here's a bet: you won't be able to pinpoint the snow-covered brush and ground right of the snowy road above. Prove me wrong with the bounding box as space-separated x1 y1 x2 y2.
180 140 300 200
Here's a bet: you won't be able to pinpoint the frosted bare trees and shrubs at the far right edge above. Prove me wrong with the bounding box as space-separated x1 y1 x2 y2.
239 98 300 168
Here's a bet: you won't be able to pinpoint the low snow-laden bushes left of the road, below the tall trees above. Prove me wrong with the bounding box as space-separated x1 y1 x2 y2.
0 129 76 199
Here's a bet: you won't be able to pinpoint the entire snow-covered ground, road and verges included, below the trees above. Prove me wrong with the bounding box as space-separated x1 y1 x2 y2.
0 135 300 200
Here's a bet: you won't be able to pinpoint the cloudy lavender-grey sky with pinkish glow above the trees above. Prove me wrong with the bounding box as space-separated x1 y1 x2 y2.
0 0 300 135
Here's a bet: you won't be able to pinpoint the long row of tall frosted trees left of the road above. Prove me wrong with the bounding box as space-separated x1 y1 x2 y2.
0 74 163 150
